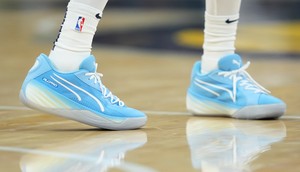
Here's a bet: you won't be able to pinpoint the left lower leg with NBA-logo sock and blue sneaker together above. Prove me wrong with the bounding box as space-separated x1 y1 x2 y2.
20 0 147 130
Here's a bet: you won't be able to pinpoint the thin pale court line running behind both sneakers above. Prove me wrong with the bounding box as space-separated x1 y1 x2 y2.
0 106 300 120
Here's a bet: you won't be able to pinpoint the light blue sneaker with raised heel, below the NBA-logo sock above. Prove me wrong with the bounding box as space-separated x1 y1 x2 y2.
20 54 147 130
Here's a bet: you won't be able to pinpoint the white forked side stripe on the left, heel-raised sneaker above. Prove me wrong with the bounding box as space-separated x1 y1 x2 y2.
51 73 105 112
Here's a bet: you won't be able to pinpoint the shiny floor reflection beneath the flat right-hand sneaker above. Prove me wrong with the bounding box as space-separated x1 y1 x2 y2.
186 117 286 172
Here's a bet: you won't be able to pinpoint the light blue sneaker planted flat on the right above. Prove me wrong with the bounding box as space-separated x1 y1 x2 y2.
186 54 286 119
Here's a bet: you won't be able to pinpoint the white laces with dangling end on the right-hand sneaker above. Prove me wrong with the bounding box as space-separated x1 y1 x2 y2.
218 62 271 102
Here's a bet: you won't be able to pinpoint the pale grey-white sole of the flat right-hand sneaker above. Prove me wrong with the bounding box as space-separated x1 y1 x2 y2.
186 94 286 119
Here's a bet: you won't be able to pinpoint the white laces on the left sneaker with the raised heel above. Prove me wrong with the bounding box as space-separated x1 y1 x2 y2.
85 63 125 106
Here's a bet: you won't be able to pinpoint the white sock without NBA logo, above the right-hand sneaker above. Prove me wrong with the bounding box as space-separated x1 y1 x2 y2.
201 0 241 74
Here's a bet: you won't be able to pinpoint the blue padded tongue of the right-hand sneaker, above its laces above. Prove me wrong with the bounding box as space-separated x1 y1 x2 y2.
218 54 243 71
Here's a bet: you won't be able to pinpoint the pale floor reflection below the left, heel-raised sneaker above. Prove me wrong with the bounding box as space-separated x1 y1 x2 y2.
20 131 147 172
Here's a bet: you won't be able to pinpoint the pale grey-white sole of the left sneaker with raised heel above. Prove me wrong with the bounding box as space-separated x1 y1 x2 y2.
19 91 147 130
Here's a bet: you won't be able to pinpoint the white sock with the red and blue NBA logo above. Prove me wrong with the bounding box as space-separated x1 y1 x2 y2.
49 0 107 72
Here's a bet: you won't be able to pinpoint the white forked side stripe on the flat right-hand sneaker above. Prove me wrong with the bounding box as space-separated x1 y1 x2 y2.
194 78 234 101
